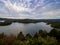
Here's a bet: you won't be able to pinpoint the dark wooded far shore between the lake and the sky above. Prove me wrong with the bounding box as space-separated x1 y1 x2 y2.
0 19 60 29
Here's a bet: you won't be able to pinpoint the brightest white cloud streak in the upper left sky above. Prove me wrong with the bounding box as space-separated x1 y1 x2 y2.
4 0 31 12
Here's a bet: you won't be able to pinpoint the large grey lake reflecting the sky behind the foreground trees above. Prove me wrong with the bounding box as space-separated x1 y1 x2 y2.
0 22 52 35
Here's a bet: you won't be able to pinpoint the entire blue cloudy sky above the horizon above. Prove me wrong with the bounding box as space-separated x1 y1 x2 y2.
0 0 60 19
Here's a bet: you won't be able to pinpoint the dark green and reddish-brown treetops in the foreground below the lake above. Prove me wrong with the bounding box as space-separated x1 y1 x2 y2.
0 29 60 45
